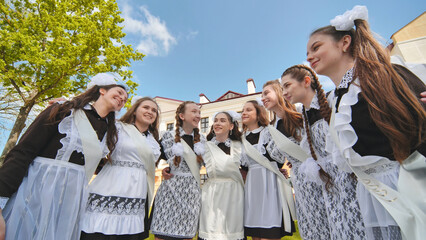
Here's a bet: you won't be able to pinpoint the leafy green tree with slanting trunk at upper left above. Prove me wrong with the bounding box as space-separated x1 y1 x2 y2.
0 0 144 161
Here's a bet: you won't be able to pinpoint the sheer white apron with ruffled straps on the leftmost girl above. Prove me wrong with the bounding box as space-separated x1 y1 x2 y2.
3 110 108 240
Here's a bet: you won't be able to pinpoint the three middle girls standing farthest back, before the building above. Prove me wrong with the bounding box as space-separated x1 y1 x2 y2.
151 101 295 240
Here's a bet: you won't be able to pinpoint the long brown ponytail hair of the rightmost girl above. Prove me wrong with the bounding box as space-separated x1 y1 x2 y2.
311 19 426 162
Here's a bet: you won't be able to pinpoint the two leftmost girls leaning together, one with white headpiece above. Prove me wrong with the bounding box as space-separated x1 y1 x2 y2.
0 74 164 240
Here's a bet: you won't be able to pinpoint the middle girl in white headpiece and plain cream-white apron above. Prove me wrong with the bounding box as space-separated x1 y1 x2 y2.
198 111 244 240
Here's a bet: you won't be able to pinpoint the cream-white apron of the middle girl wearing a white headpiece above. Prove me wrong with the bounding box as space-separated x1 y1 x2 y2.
198 141 244 240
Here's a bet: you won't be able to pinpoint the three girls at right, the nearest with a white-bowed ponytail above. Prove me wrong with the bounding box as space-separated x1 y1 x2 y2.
263 6 426 239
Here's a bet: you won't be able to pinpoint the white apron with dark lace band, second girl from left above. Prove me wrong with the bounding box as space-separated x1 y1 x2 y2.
81 122 159 235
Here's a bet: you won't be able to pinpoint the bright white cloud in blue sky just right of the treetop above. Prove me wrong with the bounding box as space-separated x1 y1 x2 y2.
122 4 177 56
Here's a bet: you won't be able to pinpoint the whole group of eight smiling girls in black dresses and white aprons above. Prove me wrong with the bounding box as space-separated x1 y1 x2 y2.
0 6 426 240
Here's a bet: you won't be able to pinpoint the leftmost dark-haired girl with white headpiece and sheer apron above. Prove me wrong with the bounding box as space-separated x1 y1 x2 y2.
0 74 127 240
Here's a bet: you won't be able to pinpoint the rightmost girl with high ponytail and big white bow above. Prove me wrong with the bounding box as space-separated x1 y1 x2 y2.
307 6 426 239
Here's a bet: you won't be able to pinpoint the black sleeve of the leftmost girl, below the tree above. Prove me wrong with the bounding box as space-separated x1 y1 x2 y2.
0 104 58 197
